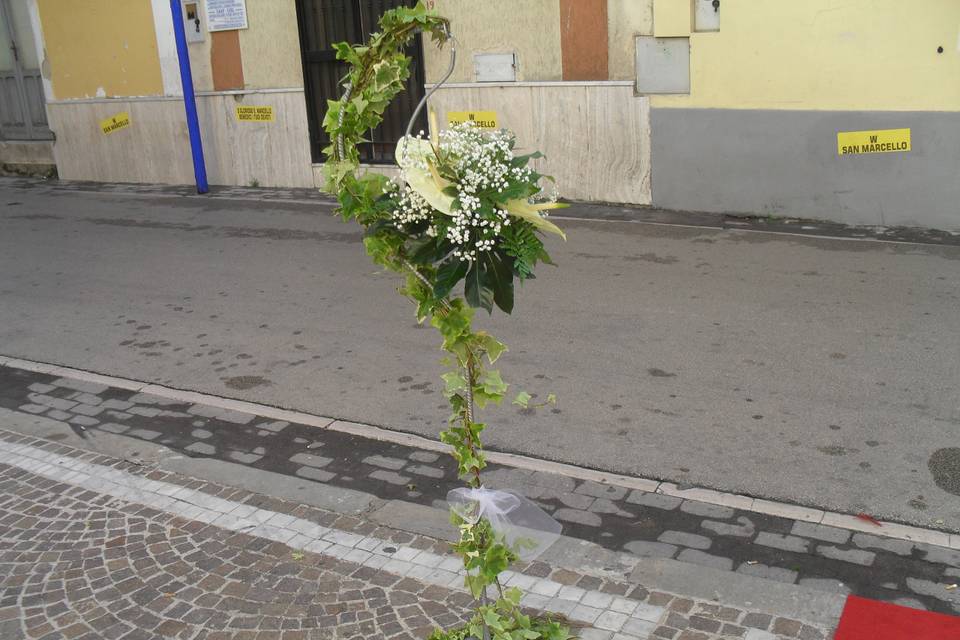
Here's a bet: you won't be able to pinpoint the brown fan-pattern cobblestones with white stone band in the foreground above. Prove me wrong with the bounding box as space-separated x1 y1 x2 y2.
0 430 829 640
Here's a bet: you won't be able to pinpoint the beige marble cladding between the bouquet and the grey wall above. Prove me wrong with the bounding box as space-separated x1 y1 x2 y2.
430 83 650 204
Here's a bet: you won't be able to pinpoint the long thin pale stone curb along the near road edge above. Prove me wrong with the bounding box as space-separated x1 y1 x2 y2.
0 355 960 550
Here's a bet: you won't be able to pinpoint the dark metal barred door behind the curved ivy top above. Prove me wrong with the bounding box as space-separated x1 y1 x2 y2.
297 0 427 164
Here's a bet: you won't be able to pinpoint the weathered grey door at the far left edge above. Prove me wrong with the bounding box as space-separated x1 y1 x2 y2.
0 0 53 140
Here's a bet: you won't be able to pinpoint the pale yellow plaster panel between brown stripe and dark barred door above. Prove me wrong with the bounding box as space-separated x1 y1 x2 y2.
240 0 303 89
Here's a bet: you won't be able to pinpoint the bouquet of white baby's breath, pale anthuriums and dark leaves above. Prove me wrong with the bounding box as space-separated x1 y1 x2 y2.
388 117 565 313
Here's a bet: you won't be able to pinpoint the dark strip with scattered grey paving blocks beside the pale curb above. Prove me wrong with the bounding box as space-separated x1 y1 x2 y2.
0 367 960 614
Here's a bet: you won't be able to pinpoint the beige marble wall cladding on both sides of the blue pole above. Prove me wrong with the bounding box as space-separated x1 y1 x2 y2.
48 91 313 187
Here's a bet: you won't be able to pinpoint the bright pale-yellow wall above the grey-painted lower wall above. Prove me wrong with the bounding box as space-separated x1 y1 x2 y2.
651 0 960 111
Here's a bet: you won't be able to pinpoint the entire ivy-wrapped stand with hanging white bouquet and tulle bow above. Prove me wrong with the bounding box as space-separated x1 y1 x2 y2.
324 2 572 640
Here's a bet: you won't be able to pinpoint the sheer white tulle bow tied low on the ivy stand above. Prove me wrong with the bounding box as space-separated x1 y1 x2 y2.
447 487 563 560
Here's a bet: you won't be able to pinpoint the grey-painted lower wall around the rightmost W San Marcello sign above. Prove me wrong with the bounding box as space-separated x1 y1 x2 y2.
650 109 960 230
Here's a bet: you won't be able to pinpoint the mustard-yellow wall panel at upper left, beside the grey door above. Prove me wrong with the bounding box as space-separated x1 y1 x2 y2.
37 0 163 100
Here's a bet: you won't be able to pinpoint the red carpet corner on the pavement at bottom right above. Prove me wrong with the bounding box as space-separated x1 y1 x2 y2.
834 596 960 640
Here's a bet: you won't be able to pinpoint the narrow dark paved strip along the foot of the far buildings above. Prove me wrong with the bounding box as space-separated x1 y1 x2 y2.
0 177 960 246
